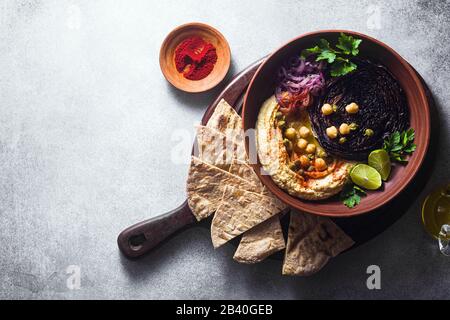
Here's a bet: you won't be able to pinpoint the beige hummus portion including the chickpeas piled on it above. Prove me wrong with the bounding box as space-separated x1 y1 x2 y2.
256 96 353 200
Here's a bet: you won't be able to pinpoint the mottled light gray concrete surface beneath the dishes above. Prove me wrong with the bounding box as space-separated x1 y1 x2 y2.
0 0 450 299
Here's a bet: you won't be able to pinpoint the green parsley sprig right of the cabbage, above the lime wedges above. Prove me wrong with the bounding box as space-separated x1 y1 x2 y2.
383 128 417 163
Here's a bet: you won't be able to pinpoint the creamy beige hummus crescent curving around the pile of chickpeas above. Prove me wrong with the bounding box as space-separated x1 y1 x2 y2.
256 96 353 200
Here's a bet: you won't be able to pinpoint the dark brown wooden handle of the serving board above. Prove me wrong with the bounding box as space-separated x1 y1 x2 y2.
117 200 195 259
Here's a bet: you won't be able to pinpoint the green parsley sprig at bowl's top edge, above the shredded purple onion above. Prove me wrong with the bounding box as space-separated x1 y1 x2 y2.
302 33 362 77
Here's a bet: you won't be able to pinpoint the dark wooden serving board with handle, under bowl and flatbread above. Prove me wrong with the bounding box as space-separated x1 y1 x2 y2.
117 58 439 259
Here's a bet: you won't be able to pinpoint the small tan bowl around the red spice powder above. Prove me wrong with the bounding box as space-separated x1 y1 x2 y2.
159 22 231 93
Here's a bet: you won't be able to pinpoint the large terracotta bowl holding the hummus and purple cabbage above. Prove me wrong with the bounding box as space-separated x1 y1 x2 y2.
242 30 430 217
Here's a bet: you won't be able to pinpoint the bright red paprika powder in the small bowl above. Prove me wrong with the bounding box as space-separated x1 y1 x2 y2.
175 36 217 80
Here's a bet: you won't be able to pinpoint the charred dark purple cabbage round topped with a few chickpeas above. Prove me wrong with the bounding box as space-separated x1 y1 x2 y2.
309 60 409 160
